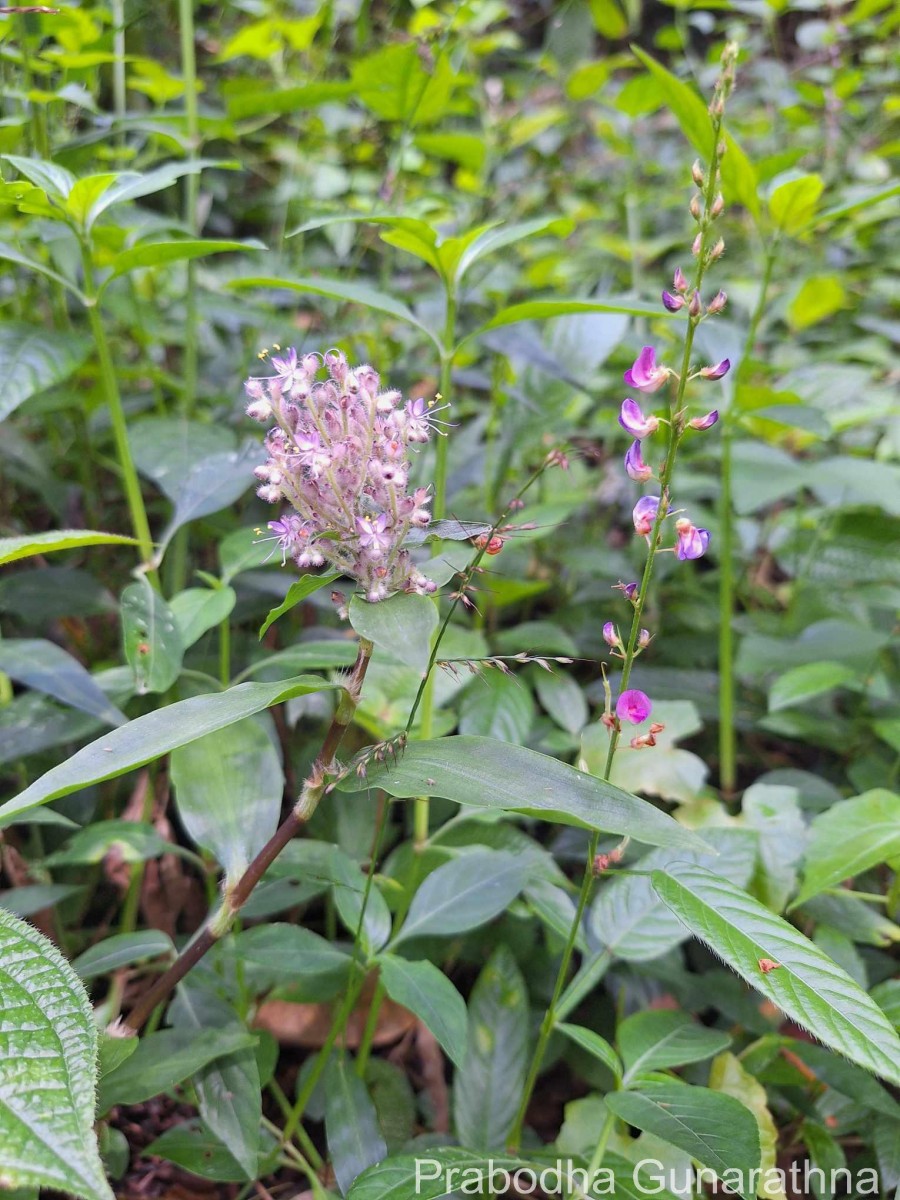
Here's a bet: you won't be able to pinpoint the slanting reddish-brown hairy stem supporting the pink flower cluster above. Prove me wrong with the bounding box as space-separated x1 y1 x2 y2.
127 637 372 1033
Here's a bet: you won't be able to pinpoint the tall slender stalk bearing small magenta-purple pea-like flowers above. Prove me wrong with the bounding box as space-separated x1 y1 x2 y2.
508 43 737 1152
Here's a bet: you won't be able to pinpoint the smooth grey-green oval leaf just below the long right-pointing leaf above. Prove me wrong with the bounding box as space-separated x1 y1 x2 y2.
392 850 527 946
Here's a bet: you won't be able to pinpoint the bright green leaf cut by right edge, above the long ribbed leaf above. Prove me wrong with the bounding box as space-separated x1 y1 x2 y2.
792 787 900 907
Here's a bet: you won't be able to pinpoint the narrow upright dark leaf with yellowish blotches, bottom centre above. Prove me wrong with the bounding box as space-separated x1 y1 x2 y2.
454 946 529 1150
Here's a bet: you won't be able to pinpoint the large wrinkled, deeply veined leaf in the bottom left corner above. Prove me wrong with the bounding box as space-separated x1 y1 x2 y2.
0 908 113 1200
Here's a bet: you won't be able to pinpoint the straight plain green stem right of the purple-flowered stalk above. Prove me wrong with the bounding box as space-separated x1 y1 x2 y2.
719 245 778 794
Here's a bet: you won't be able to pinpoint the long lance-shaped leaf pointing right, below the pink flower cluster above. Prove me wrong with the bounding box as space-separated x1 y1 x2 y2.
340 722 706 850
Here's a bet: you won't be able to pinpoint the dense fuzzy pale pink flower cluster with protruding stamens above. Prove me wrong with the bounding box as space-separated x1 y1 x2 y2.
245 349 436 601
